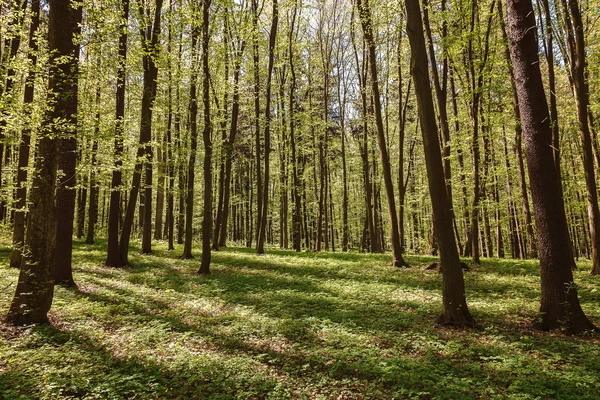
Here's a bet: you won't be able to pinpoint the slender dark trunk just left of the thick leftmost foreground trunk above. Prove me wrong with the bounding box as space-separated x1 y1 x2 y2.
10 0 40 268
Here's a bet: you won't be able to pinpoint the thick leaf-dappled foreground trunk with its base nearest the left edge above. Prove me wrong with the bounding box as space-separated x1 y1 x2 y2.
6 0 81 325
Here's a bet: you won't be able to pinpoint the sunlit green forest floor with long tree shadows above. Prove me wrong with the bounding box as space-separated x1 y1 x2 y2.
0 240 600 399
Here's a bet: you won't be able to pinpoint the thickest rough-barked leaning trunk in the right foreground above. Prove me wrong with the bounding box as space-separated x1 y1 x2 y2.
507 0 595 333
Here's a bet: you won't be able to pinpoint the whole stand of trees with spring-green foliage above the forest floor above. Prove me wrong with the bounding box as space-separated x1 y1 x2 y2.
0 0 600 332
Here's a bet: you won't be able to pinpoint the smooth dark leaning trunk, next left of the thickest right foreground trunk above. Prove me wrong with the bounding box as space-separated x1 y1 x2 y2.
405 0 474 326
